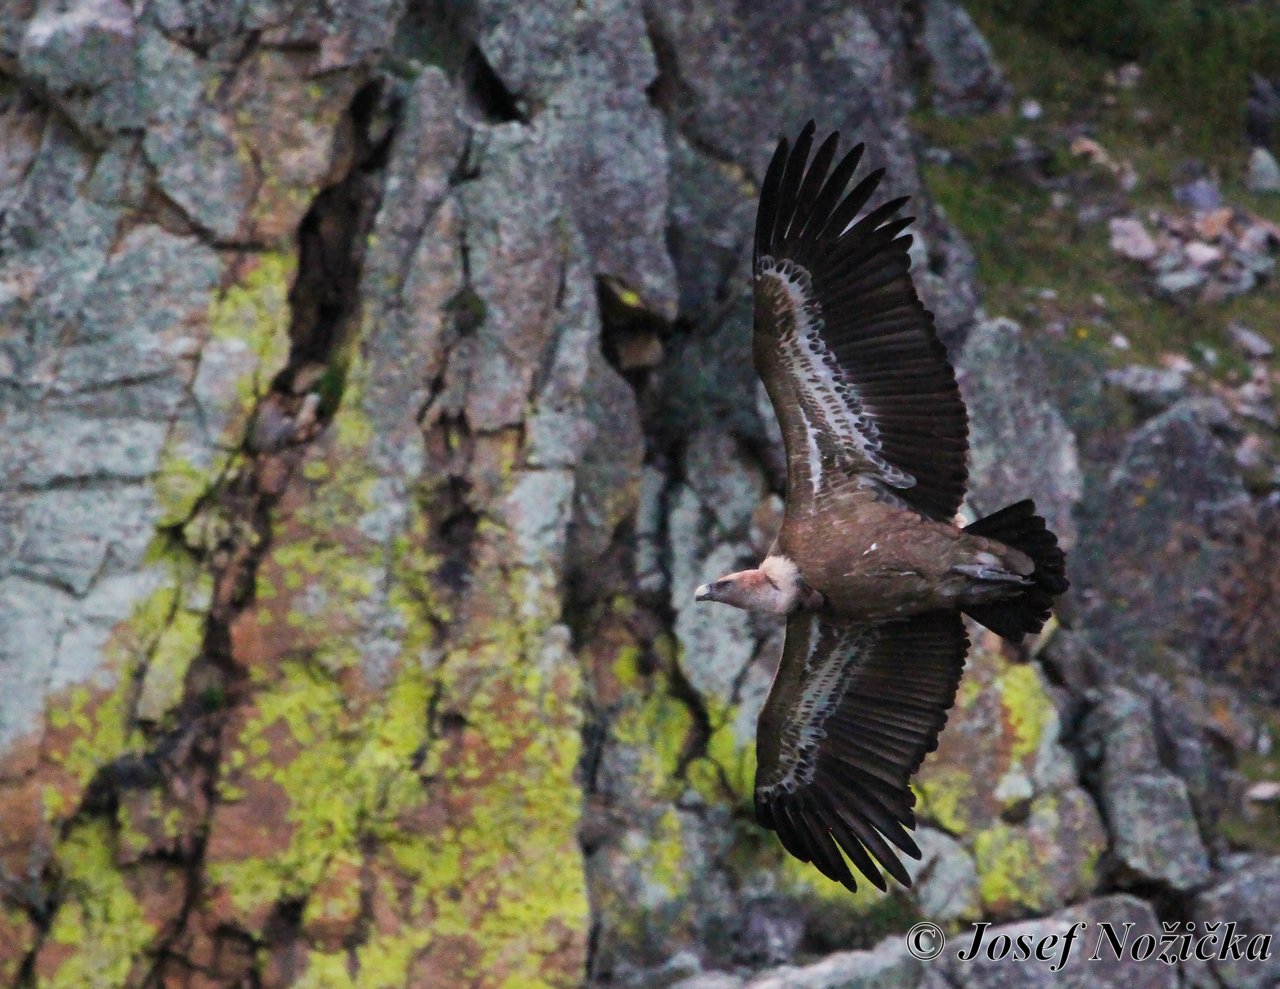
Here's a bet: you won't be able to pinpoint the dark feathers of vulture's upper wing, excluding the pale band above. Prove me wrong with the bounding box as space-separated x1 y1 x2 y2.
755 122 968 519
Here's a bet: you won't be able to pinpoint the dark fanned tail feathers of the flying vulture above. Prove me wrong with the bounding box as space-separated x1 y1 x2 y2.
961 498 1070 641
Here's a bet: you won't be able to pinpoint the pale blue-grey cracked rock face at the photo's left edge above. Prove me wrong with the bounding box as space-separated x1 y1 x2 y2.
0 122 240 741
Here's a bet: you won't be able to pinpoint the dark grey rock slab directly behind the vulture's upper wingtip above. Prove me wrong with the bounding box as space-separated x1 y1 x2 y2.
646 0 975 344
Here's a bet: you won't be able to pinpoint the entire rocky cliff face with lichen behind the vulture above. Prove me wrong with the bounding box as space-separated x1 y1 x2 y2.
0 0 1263 986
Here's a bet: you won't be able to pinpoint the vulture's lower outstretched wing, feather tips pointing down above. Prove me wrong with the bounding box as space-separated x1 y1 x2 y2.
755 612 969 889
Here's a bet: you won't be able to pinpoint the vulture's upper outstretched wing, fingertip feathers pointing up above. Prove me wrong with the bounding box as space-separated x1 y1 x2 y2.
753 122 968 519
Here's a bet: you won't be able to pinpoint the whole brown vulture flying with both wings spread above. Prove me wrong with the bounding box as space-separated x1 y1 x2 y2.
695 122 1068 889
